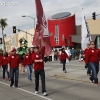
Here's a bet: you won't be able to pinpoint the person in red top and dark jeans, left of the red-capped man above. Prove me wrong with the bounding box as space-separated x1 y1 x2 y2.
1 52 10 81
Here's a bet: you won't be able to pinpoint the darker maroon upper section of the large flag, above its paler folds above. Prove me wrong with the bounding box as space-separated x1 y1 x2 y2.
35 0 47 28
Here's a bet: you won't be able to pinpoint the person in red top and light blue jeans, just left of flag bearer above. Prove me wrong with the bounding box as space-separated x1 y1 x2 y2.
24 49 33 82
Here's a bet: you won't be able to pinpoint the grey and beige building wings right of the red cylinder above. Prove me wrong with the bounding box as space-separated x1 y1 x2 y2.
71 19 100 48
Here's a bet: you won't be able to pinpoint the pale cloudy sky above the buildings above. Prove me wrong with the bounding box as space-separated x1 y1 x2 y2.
0 0 100 34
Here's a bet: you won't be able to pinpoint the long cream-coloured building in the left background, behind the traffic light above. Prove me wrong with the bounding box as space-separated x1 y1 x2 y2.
5 29 34 51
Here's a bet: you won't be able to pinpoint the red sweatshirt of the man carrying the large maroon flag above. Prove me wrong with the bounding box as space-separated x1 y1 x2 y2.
32 47 45 70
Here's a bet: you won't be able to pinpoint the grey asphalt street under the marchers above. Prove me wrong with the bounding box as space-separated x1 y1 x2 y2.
0 60 100 100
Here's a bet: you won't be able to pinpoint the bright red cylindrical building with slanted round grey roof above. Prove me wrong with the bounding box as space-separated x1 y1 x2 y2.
48 12 76 47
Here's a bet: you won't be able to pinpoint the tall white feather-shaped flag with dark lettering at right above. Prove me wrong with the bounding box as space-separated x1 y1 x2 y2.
81 13 91 50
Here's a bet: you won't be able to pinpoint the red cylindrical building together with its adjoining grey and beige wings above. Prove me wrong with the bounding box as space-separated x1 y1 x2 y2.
48 12 100 48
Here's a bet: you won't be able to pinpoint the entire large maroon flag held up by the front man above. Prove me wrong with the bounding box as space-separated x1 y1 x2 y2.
32 0 52 55
